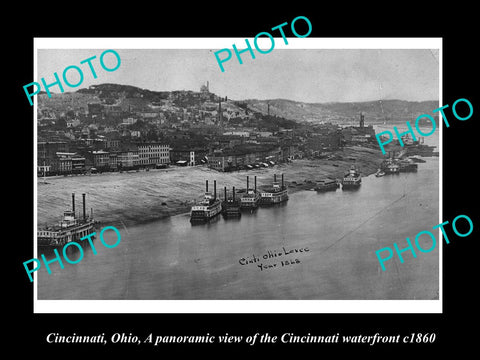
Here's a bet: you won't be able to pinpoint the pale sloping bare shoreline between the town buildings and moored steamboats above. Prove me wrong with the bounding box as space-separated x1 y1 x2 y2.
37 146 432 227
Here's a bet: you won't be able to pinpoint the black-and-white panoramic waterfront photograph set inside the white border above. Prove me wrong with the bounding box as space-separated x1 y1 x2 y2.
34 38 442 312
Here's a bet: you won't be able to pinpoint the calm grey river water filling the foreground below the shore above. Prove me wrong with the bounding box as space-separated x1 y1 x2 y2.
37 129 439 300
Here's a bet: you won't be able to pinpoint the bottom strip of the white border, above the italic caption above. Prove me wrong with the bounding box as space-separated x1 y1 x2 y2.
34 300 441 314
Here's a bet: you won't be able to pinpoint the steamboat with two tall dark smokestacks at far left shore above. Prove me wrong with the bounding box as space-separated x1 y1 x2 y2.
37 194 96 248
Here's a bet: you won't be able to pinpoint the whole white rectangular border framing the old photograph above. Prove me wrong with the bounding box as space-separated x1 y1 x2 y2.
33 37 443 313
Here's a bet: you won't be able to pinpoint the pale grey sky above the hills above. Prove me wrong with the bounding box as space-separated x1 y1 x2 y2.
34 44 439 103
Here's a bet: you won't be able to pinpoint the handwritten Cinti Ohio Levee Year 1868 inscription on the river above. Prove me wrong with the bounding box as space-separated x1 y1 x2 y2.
238 247 310 271
